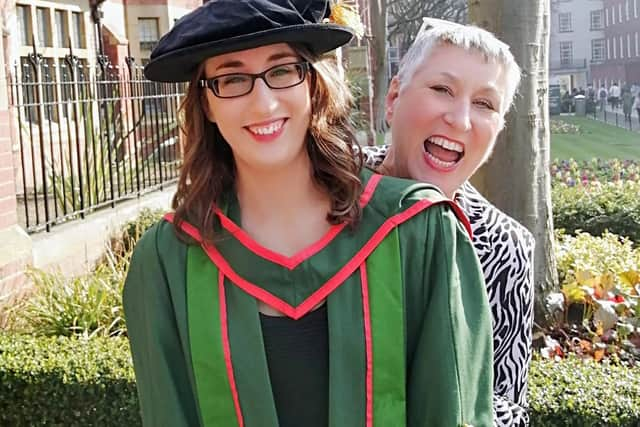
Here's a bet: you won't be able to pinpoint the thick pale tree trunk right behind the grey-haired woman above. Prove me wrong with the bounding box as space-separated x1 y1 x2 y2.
469 0 558 323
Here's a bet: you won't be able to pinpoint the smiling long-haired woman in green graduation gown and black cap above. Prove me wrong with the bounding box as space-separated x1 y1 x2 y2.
124 0 492 427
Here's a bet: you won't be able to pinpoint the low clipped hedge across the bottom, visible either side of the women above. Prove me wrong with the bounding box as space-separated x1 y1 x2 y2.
0 334 640 427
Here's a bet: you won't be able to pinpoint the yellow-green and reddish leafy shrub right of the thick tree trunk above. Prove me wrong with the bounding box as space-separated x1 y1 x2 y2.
536 232 640 364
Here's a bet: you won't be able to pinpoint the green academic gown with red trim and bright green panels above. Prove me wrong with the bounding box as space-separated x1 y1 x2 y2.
124 171 493 427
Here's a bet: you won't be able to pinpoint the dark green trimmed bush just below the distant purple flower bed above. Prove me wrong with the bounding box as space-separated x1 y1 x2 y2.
552 181 640 243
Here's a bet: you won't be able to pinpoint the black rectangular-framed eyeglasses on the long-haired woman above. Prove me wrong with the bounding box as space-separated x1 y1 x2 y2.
200 62 309 98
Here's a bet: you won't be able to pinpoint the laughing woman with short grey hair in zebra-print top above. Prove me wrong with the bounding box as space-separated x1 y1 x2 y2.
363 18 534 427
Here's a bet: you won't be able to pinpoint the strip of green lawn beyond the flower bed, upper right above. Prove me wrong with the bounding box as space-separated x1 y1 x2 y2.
551 116 640 160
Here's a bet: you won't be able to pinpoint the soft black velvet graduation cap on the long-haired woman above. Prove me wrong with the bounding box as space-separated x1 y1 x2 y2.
144 0 353 82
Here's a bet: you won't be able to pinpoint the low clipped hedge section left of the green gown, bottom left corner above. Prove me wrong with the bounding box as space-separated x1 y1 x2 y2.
0 334 141 427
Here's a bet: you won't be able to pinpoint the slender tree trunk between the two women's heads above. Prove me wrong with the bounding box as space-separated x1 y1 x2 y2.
369 0 388 132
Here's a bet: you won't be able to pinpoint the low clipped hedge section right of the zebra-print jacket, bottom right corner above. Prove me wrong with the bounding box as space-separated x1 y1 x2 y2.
529 357 640 427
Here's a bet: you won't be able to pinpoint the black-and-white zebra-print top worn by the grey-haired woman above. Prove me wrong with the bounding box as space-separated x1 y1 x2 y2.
362 146 534 427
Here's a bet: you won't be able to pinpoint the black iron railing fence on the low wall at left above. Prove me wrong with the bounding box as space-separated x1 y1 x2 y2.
9 47 185 232
